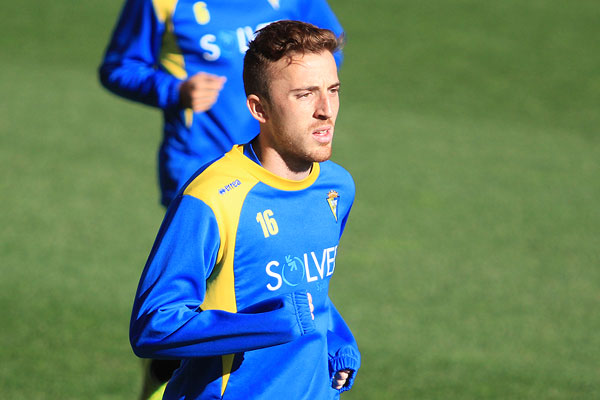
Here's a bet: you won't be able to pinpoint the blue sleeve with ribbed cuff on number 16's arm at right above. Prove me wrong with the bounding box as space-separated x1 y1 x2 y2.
327 298 360 392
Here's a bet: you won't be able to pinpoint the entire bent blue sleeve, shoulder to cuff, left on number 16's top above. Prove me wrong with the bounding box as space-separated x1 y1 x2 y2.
130 196 315 359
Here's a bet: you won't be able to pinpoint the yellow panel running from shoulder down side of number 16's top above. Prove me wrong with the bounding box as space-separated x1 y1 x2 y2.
184 151 258 396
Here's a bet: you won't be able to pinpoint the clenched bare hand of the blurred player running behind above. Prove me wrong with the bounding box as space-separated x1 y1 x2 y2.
179 72 227 112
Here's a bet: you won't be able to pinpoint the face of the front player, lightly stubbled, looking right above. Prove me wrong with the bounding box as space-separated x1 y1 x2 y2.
261 51 340 169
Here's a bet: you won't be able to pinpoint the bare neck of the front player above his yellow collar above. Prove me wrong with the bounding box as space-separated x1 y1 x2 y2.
252 135 313 181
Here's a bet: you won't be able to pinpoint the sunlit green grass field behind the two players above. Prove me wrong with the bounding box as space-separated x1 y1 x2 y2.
0 0 600 400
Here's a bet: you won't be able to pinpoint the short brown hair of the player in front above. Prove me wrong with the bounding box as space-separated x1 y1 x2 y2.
244 20 343 99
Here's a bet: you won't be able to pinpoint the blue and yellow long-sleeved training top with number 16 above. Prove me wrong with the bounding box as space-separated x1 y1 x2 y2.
130 145 360 400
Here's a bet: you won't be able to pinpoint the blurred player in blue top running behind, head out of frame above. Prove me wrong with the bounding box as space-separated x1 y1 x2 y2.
99 0 342 206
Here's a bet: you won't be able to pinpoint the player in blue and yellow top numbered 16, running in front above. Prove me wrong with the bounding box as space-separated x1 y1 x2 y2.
130 21 360 399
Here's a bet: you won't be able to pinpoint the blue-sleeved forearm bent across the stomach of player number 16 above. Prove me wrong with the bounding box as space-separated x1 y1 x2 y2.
130 292 315 358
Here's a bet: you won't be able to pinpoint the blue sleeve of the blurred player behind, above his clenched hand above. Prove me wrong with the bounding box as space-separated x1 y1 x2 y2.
99 0 181 109
